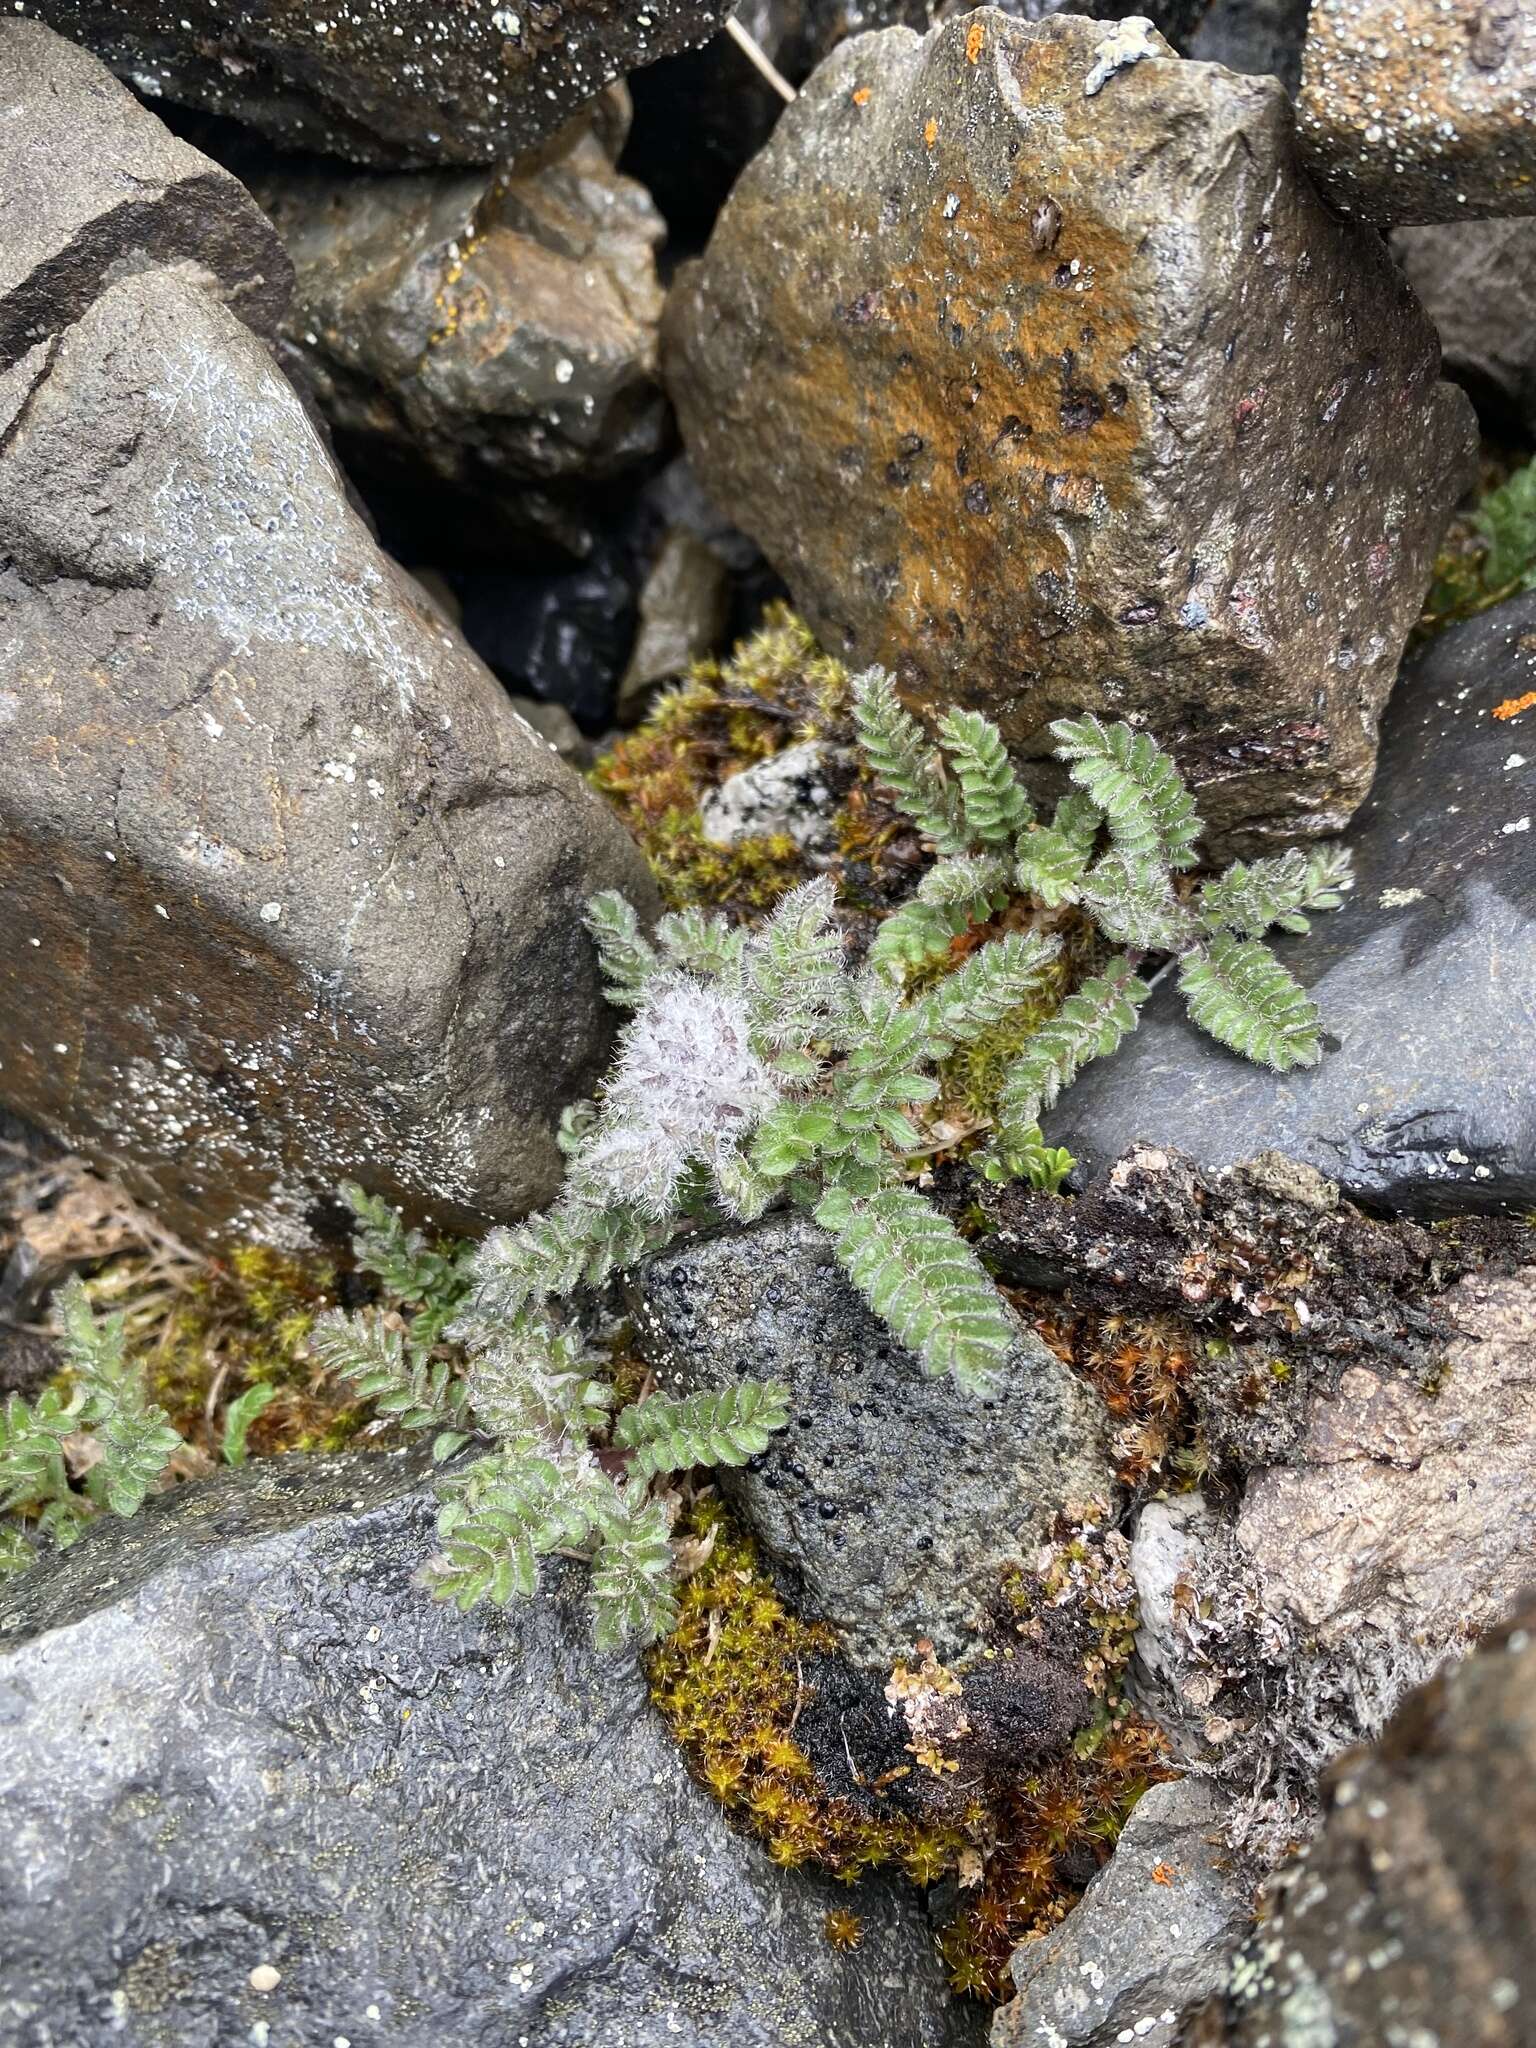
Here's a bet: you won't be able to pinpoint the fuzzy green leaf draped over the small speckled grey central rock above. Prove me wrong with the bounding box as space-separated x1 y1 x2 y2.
815 1188 1014 1395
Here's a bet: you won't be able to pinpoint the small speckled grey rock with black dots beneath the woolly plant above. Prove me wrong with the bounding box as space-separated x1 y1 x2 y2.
633 1217 1112 1667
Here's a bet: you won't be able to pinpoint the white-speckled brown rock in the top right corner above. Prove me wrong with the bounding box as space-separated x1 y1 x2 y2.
1296 0 1536 227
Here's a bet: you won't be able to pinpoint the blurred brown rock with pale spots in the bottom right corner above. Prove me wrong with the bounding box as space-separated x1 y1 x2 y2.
1190 1606 1536 2048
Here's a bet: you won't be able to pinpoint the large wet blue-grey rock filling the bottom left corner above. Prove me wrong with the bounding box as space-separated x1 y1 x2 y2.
0 1456 977 2048
